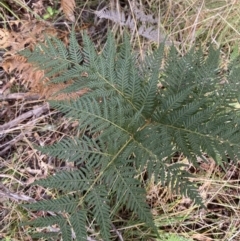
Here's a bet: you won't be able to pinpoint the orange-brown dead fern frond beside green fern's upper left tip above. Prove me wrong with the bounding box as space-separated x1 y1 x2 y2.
0 21 87 100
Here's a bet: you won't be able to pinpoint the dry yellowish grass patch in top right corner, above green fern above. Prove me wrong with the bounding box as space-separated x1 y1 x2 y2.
159 0 240 52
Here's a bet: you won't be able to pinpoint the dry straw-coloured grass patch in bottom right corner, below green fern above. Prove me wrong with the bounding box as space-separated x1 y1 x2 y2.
146 159 240 241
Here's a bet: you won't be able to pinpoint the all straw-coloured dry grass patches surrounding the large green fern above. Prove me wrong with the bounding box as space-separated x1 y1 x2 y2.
0 0 240 241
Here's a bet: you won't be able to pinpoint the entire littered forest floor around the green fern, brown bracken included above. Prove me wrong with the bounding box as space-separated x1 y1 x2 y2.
0 0 240 241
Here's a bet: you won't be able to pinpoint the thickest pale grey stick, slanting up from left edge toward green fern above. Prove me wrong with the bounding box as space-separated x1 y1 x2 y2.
0 103 49 136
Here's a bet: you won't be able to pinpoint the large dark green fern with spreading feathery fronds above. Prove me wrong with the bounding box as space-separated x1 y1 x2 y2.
22 33 240 241
